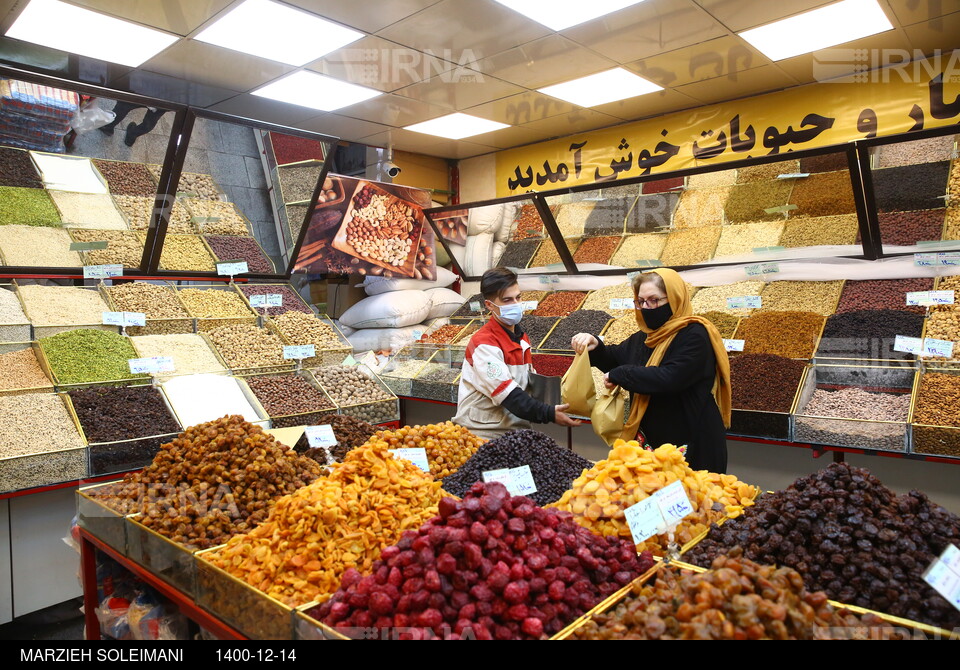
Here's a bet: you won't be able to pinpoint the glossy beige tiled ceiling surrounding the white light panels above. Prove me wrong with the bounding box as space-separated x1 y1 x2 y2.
0 0 960 158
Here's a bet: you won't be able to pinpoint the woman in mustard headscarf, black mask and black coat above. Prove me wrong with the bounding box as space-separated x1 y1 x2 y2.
572 268 730 472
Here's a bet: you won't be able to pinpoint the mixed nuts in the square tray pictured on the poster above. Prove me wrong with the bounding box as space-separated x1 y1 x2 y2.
347 187 416 268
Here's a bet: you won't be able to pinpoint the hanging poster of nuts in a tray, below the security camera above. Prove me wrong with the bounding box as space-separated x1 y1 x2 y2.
294 175 436 280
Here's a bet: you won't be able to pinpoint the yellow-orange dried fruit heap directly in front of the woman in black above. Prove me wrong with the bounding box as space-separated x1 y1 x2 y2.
554 440 759 556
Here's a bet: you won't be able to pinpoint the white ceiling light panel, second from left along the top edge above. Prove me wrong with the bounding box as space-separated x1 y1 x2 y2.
195 0 363 66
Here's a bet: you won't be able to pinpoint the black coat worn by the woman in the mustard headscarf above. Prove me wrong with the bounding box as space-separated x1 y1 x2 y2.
590 323 727 472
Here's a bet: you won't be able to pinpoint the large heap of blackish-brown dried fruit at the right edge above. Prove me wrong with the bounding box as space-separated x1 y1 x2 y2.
685 463 960 629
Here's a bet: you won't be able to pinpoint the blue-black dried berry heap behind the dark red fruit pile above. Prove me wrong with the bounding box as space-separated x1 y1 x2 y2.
443 430 592 505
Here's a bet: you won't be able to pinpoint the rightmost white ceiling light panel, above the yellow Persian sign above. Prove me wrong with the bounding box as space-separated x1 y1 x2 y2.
738 0 893 60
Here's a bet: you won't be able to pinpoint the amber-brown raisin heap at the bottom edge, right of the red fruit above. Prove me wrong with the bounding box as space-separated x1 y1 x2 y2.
572 549 898 640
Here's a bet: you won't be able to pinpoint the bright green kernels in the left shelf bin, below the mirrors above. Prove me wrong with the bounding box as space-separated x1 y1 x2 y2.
40 329 149 384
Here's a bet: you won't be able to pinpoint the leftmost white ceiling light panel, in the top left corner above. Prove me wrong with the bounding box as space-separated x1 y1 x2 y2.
6 0 179 67
